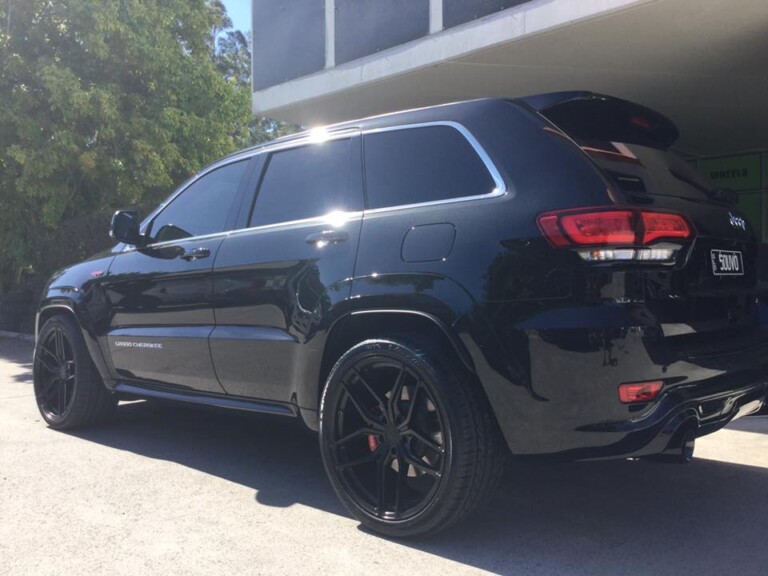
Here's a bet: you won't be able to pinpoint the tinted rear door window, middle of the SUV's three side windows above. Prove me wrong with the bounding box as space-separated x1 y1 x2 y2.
249 138 351 226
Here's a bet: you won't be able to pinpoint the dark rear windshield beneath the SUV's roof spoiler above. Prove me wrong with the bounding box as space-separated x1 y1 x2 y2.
578 142 716 200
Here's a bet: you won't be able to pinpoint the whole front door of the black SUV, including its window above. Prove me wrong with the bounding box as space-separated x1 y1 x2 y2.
104 160 251 392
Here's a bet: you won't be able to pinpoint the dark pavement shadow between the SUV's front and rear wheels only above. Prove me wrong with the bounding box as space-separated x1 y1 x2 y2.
73 401 346 514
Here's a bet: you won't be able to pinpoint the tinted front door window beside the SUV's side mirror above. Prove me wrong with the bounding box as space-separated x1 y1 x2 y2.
151 160 248 242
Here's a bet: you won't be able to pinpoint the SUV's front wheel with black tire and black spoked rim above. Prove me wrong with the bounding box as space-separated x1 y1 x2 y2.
33 316 117 430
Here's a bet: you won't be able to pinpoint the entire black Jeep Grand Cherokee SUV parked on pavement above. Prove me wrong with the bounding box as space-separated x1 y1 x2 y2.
34 93 768 536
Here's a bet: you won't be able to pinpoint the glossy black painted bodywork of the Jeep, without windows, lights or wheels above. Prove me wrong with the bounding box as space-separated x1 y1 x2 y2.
40 97 768 458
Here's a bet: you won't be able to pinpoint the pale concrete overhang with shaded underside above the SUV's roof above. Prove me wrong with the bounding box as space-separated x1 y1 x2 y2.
253 0 768 156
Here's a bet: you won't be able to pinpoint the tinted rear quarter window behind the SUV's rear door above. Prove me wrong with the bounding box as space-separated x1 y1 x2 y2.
365 126 496 208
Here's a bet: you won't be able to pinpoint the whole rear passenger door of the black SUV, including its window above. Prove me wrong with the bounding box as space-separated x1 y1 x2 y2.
210 132 363 400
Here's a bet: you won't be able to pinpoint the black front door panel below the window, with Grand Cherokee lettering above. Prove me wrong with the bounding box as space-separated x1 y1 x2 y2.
103 236 224 392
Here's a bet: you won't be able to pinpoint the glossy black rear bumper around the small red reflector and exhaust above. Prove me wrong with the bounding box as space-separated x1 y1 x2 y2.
475 310 768 459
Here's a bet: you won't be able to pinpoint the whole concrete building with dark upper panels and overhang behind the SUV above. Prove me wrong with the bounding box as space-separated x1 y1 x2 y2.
252 0 768 240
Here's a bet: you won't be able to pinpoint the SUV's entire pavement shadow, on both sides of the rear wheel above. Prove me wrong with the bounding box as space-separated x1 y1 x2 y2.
72 402 768 575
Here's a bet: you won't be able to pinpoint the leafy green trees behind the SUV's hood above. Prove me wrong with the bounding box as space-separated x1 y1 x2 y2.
0 0 289 288
